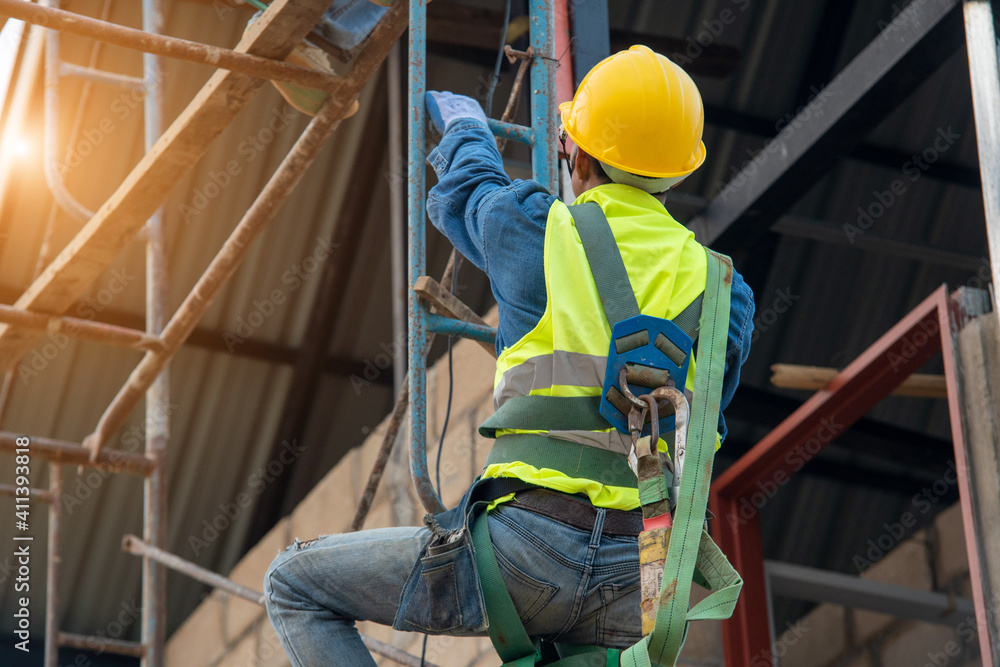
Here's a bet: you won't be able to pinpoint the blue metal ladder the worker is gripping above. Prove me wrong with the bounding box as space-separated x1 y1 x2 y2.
407 0 558 513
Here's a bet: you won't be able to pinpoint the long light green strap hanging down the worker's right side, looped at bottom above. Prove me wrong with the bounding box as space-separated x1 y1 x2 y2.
621 251 743 667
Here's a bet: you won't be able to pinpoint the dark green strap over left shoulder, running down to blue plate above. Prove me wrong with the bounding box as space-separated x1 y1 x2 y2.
569 202 641 328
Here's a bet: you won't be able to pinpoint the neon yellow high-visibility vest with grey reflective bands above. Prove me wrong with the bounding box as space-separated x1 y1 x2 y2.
483 184 718 510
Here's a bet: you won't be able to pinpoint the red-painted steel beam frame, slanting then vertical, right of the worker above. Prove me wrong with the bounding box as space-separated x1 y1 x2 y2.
711 285 952 666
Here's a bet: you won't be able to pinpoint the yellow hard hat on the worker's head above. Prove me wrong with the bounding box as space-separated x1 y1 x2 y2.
559 45 705 178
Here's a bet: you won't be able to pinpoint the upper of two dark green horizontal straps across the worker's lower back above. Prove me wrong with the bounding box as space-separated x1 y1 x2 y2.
479 396 611 438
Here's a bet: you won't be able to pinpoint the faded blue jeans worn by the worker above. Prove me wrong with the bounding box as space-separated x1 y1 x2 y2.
264 500 641 667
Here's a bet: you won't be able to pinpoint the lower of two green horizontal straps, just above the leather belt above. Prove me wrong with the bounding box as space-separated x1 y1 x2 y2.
486 433 636 489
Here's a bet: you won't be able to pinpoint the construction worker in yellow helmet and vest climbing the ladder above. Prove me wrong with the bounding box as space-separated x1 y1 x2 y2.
265 46 754 667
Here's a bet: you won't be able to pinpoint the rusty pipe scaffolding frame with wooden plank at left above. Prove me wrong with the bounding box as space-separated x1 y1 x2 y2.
0 0 421 667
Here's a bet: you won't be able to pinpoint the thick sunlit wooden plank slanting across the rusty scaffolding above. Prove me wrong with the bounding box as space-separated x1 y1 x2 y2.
0 0 338 372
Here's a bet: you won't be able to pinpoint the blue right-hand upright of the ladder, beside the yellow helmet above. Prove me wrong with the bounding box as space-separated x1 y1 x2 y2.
529 0 559 194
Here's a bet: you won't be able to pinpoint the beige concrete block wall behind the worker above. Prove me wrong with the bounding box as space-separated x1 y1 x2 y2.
167 320 975 667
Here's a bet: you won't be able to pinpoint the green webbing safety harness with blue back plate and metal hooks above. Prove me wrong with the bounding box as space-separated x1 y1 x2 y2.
472 202 743 667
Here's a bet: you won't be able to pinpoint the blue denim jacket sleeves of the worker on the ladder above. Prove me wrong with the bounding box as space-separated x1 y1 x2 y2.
427 124 754 439
